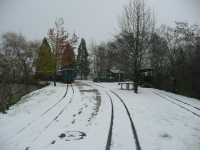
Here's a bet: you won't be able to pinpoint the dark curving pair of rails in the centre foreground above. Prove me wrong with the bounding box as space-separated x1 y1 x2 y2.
91 84 141 150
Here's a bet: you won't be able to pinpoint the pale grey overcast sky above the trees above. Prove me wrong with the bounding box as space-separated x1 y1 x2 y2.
0 0 200 42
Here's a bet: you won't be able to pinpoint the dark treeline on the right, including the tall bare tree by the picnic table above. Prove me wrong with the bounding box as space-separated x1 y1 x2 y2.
92 0 200 98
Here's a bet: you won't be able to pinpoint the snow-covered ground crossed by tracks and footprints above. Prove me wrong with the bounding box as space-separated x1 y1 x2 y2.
0 81 200 150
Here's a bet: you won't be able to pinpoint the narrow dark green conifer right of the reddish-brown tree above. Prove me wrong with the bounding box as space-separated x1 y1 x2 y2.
77 38 90 80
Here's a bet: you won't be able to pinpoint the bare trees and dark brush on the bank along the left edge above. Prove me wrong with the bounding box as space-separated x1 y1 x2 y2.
0 32 40 111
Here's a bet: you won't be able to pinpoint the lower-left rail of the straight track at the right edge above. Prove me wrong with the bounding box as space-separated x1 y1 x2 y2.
152 91 200 118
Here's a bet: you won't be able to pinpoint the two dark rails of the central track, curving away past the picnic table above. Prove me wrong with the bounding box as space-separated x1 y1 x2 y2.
91 84 141 150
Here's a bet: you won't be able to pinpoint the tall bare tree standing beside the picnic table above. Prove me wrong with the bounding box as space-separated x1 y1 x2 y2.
120 0 154 93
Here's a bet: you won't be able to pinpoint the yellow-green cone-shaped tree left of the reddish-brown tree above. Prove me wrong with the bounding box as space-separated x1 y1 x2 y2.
36 38 55 78
